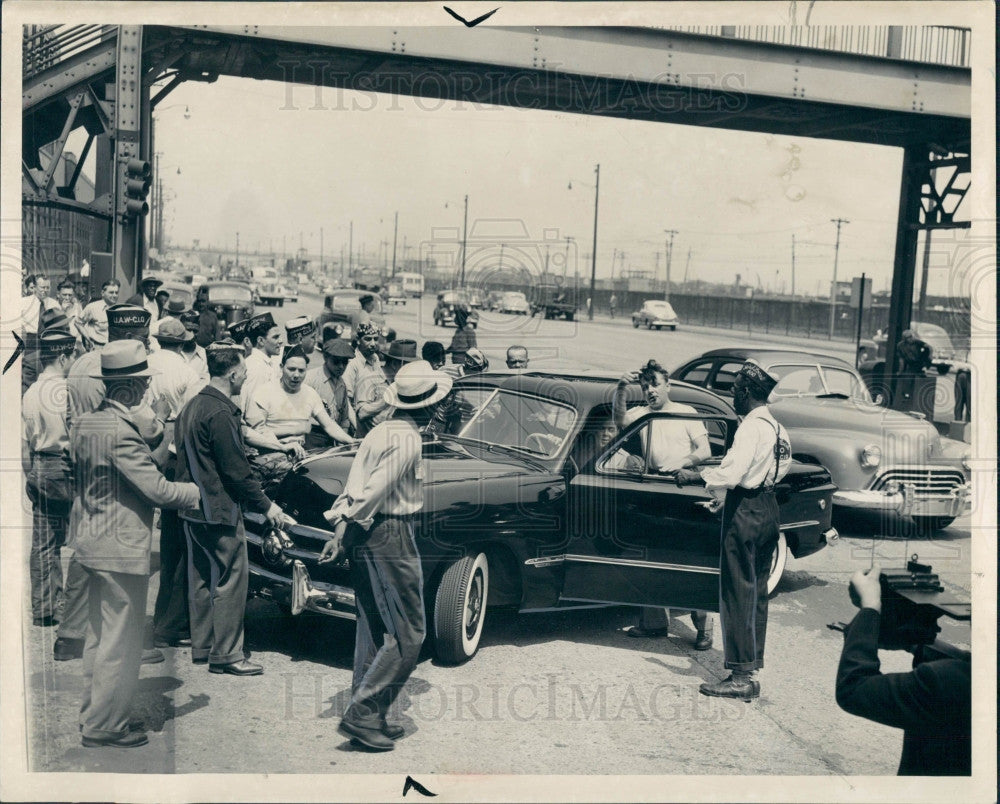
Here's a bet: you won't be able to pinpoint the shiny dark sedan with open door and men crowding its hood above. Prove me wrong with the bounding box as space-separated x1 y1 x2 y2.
247 372 836 662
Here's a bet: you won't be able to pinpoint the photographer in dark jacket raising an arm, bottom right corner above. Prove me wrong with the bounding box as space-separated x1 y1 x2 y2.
837 565 972 776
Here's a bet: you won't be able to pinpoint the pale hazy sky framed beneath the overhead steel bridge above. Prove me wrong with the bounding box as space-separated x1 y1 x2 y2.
115 41 960 294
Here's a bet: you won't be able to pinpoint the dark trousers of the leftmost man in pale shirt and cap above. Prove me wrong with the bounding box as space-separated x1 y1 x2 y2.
25 453 73 618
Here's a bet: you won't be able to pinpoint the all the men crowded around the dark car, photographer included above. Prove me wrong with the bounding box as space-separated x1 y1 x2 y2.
21 275 968 773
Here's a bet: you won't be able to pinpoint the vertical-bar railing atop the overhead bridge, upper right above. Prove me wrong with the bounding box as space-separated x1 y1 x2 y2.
665 25 972 67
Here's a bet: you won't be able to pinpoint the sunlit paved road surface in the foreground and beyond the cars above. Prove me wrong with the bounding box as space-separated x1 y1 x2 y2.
23 297 971 784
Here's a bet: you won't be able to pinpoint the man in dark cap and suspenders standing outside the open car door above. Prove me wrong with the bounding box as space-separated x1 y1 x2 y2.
676 360 792 701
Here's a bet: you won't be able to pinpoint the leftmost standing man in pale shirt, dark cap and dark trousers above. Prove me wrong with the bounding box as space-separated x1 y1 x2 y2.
21 329 76 626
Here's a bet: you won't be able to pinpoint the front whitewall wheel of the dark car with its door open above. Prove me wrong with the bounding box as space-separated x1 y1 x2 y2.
434 553 490 664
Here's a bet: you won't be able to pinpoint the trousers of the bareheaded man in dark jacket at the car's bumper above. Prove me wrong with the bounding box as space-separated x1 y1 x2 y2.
183 519 250 664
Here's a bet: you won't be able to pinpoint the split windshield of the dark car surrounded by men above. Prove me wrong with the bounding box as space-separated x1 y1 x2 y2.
459 390 577 457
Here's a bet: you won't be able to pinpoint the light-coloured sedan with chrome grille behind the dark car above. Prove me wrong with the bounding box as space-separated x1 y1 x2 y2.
671 347 971 530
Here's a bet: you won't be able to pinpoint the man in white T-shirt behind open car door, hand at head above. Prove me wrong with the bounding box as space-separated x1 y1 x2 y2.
614 360 712 650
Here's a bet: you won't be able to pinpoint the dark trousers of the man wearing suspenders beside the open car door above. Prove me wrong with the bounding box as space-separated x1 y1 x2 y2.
719 486 778 672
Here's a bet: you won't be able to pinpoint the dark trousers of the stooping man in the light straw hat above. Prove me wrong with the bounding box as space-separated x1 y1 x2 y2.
344 516 426 721
